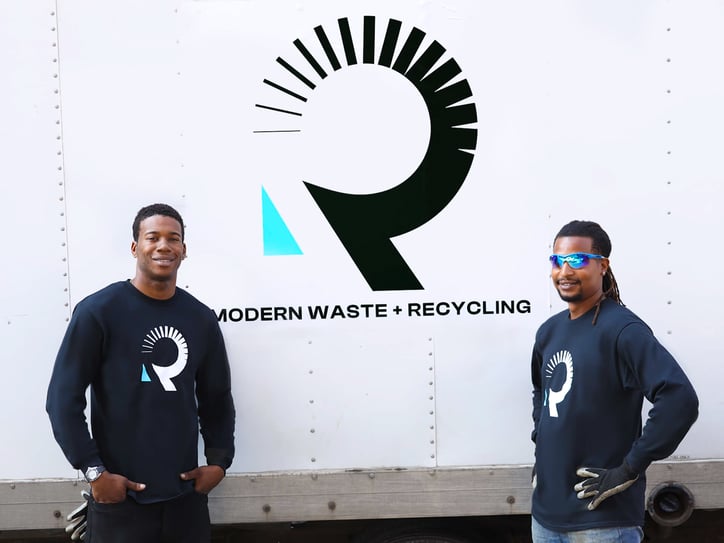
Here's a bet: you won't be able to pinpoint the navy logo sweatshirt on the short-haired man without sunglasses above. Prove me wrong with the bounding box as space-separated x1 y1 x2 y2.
46 281 235 503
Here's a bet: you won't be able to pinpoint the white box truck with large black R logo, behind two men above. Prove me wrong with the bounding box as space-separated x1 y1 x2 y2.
0 0 724 542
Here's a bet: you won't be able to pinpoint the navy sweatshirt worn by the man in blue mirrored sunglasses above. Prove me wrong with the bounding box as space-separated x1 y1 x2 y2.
532 299 699 532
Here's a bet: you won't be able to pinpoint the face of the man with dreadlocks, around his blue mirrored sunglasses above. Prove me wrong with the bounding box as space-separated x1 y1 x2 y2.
551 236 608 319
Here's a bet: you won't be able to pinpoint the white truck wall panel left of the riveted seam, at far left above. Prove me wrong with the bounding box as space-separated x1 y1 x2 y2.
0 0 72 478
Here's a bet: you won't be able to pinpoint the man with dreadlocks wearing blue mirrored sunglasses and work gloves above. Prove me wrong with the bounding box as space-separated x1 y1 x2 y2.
532 221 699 543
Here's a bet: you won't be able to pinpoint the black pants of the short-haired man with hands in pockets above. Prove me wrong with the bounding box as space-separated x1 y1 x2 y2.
87 492 211 543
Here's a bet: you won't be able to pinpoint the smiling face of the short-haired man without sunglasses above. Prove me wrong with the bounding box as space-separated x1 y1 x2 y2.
131 215 186 297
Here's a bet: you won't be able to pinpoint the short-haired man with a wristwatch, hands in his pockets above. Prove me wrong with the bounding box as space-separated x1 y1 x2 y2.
46 204 235 543
